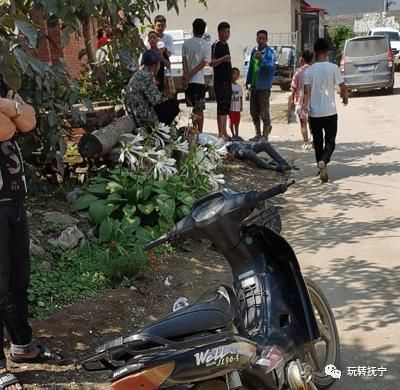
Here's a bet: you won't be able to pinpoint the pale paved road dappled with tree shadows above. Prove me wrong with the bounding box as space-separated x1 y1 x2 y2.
206 77 400 390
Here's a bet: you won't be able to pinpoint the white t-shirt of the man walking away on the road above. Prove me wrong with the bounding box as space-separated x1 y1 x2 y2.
304 62 344 118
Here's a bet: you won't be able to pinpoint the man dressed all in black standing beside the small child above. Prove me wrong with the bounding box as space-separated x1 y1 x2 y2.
210 22 232 140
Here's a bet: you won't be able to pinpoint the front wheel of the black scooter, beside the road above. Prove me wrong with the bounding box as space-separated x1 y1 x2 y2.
304 278 340 389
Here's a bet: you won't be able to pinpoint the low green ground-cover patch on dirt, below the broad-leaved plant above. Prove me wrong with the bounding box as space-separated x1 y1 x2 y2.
28 242 149 318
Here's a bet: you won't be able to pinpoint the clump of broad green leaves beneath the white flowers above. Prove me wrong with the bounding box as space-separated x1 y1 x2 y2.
72 167 201 242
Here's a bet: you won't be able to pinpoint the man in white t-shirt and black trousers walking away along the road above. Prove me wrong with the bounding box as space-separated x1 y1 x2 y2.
300 38 348 183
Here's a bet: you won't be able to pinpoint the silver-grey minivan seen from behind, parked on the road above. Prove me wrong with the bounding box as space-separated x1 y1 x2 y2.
340 35 394 93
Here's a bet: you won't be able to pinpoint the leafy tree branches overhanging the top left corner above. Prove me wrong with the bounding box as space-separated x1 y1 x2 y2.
0 0 206 166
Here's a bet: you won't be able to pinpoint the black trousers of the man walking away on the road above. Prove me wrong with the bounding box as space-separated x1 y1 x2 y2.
310 114 337 164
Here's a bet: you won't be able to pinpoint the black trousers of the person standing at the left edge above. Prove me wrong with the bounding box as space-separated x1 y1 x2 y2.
0 201 32 367
